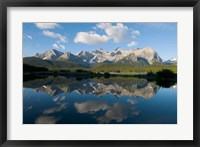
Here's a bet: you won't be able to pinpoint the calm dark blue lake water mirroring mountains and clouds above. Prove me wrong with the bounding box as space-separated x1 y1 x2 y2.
23 77 177 124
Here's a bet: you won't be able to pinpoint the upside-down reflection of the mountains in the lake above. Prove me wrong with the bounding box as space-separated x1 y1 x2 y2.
24 77 160 99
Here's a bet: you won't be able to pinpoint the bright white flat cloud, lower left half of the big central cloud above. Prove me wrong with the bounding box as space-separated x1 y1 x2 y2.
74 32 110 44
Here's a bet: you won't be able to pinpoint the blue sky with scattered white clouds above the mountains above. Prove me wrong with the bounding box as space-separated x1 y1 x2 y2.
23 22 177 60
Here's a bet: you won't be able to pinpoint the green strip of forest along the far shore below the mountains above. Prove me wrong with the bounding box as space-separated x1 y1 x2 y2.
24 64 177 73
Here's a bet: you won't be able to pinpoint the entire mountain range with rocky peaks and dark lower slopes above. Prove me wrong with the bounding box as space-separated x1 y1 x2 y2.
23 47 177 68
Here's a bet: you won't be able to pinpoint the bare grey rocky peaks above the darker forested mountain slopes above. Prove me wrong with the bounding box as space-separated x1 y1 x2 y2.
35 47 166 64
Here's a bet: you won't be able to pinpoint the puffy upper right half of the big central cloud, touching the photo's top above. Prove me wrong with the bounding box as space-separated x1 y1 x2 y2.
96 23 129 43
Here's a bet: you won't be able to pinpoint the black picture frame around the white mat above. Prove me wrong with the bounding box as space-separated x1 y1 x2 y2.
0 0 200 147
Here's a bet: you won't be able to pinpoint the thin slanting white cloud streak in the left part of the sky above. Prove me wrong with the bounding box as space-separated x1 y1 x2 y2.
42 30 67 43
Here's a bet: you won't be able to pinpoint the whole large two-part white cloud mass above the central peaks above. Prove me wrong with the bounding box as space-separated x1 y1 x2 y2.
74 23 140 46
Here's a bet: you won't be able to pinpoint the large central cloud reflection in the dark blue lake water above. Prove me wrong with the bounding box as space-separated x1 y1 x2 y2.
74 100 139 123
